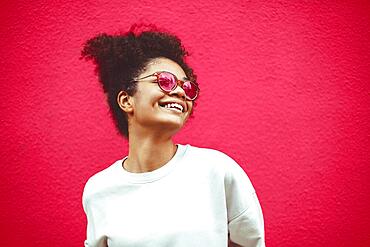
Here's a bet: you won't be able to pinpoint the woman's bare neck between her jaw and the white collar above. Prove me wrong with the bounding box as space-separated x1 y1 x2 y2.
123 133 177 173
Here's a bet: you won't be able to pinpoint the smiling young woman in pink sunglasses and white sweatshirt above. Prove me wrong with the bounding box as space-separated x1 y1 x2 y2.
82 26 265 247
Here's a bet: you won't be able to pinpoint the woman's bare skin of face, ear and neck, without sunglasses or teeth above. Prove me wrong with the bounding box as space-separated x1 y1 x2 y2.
117 58 193 173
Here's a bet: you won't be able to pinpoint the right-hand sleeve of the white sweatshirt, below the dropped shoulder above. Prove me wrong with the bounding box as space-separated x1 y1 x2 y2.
225 157 265 247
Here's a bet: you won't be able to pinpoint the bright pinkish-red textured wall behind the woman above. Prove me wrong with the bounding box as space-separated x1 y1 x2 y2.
0 0 370 247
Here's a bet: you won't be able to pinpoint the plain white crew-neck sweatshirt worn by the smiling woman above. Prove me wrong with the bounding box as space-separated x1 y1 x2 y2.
83 144 265 247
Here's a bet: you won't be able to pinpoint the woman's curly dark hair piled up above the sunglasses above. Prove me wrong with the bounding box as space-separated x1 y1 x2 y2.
81 24 196 138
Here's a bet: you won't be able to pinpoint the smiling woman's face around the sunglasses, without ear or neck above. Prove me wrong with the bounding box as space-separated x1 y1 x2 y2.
129 58 193 136
